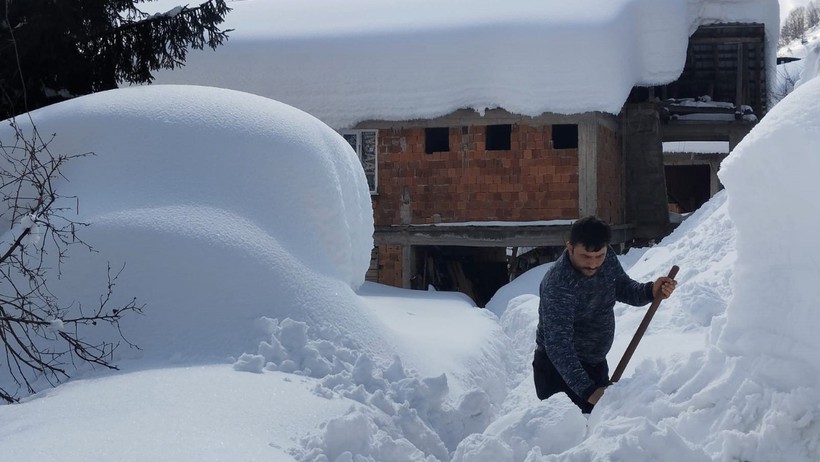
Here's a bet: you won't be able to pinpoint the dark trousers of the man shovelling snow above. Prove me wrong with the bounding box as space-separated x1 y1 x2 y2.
532 347 609 414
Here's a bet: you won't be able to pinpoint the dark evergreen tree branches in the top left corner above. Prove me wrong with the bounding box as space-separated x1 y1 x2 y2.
0 0 230 119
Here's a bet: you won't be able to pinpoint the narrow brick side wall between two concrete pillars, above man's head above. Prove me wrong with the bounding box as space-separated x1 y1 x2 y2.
597 126 625 224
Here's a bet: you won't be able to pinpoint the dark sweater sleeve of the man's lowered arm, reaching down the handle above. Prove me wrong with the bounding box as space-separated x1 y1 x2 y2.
539 281 597 399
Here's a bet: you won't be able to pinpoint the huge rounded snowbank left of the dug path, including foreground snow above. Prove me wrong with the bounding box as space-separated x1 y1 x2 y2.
0 86 520 461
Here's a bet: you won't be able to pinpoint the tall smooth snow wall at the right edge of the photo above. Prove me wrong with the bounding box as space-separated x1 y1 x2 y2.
718 79 820 378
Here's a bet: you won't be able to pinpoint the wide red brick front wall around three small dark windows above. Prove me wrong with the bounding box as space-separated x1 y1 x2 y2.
373 125 578 226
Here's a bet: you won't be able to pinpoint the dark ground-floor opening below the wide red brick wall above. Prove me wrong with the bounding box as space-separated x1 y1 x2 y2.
412 246 509 308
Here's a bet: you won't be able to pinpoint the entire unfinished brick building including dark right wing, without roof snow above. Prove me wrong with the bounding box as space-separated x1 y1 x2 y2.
341 20 767 306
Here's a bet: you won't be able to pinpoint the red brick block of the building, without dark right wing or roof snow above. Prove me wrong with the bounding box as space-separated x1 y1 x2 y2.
343 109 632 304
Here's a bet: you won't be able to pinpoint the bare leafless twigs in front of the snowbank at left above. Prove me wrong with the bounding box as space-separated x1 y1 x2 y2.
0 93 143 403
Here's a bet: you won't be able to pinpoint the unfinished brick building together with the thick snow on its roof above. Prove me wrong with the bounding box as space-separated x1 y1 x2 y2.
152 0 779 306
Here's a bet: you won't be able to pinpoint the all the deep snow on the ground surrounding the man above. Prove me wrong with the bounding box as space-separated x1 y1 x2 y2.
0 0 820 462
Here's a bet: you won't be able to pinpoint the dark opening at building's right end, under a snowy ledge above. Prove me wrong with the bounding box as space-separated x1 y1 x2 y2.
665 165 711 213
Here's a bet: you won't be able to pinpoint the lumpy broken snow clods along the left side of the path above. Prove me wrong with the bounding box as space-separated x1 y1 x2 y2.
234 316 506 462
